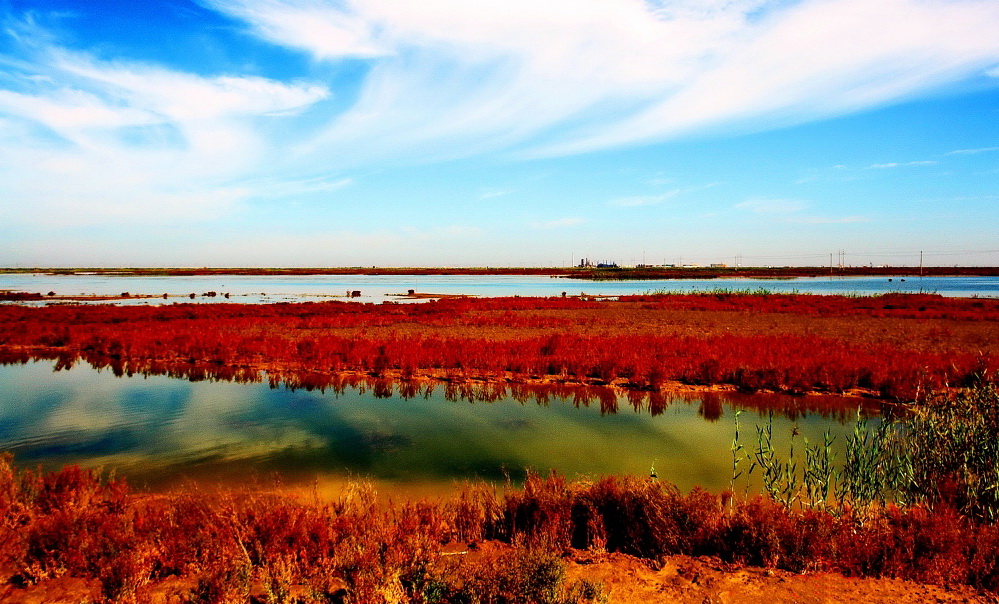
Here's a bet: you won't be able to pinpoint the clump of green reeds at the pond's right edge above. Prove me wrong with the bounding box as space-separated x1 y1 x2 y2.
732 386 999 522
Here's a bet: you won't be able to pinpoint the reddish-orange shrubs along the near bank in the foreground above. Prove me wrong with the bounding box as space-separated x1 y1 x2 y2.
0 456 999 603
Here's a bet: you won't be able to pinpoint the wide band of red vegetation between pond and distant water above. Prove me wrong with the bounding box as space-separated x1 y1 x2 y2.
0 294 999 399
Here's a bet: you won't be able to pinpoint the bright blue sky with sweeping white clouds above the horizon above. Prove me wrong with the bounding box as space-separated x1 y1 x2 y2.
0 0 999 266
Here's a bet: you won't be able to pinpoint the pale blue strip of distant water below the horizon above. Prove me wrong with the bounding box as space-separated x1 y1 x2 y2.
0 273 999 304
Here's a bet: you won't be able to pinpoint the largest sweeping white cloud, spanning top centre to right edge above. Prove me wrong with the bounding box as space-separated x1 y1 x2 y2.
201 0 999 161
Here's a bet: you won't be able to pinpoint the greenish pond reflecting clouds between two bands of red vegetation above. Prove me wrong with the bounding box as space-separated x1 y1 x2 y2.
0 362 876 495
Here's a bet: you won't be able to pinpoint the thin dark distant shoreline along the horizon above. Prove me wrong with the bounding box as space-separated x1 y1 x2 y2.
0 266 999 280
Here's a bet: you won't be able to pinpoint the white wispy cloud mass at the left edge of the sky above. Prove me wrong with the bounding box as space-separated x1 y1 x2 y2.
0 38 336 226
